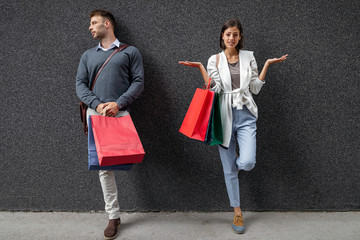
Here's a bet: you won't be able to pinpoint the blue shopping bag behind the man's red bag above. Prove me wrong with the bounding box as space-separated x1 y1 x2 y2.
88 116 133 171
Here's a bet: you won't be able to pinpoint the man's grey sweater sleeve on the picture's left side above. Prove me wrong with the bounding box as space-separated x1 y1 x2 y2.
76 52 101 109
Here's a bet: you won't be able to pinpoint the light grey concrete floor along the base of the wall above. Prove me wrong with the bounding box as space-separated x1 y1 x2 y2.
0 212 360 240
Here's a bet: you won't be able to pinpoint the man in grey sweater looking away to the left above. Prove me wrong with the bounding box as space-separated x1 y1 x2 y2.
76 10 144 239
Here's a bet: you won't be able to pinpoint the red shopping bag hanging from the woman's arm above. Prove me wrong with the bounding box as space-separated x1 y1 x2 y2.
179 79 215 141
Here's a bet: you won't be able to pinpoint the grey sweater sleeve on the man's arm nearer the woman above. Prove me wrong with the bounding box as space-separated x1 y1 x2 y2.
116 47 144 108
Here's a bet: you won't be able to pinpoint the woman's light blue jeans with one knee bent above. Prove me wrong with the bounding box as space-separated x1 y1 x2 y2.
218 106 256 207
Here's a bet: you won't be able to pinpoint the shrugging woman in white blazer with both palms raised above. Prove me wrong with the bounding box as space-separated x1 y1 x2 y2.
179 18 287 233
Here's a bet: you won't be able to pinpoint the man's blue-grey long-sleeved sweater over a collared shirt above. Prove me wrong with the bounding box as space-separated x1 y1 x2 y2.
76 46 144 110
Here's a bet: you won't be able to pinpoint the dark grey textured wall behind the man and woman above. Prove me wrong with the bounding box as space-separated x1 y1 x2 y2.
0 0 360 211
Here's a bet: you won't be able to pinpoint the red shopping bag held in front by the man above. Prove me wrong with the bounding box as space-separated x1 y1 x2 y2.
91 115 145 166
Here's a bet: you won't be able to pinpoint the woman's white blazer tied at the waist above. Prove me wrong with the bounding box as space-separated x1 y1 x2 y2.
207 50 265 147
